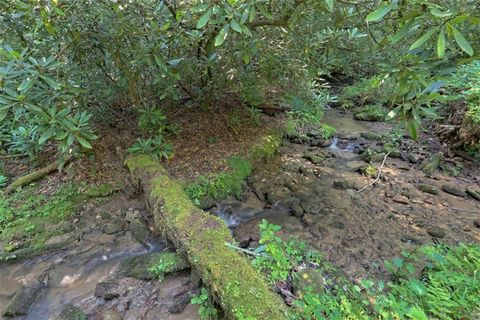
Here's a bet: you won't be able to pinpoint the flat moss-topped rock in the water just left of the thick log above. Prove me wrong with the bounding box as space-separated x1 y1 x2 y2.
119 252 190 280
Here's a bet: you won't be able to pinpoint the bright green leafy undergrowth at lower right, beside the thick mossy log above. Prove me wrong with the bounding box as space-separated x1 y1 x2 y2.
246 220 480 320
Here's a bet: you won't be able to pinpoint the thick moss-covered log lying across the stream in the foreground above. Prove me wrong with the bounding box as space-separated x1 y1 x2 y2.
126 156 286 320
